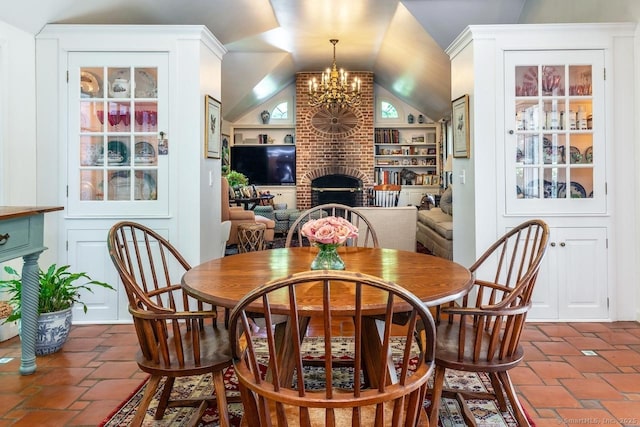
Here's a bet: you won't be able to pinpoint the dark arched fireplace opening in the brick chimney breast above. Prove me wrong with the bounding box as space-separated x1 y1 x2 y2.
311 174 364 207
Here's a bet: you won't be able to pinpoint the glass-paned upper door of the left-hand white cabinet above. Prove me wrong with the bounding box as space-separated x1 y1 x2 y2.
68 53 168 216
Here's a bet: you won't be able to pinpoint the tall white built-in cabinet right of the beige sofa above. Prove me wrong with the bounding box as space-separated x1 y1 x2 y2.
447 24 638 321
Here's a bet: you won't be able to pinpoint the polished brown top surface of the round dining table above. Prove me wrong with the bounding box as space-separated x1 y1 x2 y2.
182 247 472 308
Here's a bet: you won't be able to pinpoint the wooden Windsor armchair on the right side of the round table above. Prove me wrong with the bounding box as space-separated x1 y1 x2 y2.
429 220 549 426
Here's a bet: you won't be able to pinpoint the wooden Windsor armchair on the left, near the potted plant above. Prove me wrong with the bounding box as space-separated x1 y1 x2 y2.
107 221 231 426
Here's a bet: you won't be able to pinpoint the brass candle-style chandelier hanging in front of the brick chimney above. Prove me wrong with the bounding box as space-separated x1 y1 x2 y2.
309 39 360 108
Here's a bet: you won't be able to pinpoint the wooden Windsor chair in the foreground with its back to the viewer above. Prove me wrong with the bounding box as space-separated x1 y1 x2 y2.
229 270 435 427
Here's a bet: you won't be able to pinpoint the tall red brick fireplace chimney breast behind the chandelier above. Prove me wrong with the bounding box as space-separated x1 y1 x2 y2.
296 72 374 210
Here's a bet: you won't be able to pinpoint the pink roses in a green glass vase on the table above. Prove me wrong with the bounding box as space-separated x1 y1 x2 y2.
300 216 358 270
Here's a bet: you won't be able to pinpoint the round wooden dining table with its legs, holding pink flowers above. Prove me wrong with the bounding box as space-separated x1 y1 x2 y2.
182 247 473 385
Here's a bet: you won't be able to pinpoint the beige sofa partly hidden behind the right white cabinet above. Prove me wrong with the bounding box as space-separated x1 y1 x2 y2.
416 186 453 259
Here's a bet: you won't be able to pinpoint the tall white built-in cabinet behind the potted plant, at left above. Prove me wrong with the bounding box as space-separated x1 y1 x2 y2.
36 25 225 322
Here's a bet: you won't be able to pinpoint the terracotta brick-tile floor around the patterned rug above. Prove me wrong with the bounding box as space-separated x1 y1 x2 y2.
0 322 640 427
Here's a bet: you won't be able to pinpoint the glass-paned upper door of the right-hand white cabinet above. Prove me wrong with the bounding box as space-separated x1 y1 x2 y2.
505 51 606 213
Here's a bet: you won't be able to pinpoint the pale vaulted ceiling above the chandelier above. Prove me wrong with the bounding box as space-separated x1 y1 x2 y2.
0 0 526 121
